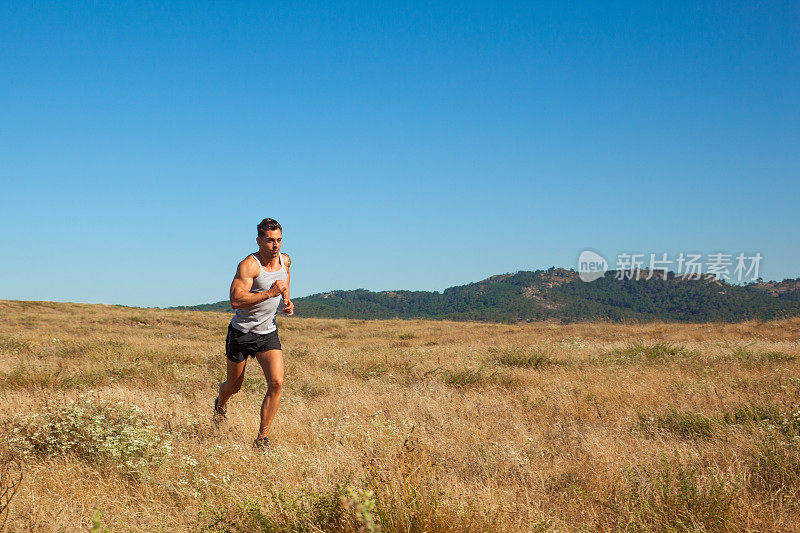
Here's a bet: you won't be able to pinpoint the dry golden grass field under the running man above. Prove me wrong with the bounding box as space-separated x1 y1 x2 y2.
0 301 800 532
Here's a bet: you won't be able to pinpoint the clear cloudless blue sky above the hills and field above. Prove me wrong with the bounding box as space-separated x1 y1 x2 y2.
0 1 800 306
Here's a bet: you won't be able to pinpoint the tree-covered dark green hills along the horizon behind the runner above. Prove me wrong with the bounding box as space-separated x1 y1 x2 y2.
170 267 800 323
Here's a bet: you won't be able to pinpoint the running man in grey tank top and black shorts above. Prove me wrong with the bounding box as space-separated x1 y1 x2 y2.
214 218 294 448
